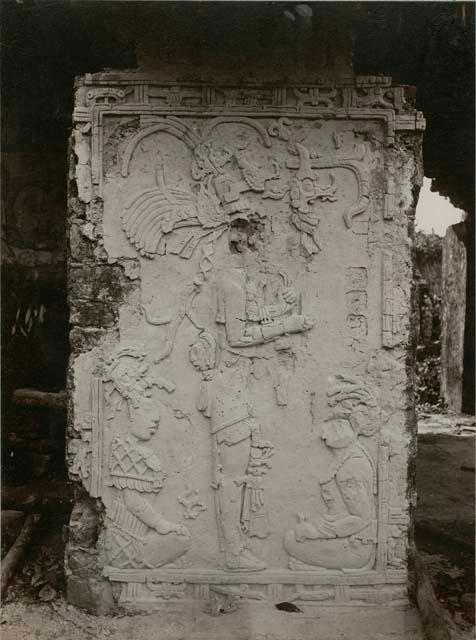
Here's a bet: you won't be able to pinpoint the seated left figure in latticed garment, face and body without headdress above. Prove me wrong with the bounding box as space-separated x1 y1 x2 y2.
106 397 191 569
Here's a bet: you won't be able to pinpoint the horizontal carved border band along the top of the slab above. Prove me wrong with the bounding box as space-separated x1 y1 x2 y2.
74 72 425 132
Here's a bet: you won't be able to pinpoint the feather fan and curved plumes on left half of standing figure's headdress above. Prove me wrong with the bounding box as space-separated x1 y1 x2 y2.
122 117 276 259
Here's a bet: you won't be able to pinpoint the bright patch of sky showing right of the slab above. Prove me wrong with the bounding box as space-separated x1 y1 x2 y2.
415 178 465 236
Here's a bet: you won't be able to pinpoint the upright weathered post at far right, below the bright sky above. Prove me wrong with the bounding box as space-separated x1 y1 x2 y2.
441 222 467 412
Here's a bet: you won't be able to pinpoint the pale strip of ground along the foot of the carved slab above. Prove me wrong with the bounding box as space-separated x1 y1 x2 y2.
1 600 424 640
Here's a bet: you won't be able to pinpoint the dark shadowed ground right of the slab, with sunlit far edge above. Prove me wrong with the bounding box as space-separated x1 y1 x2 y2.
415 415 475 637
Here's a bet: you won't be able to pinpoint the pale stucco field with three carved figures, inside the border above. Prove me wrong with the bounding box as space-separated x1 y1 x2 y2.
69 80 422 600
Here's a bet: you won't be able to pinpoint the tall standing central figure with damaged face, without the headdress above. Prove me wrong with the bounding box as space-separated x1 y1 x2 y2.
190 222 313 571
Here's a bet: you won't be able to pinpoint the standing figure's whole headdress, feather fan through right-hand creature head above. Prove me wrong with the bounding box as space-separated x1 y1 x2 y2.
122 117 368 268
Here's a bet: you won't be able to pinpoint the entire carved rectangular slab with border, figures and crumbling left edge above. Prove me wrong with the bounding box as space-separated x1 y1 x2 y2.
67 72 424 613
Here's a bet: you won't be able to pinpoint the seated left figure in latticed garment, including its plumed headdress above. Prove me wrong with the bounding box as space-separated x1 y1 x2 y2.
106 350 191 569
